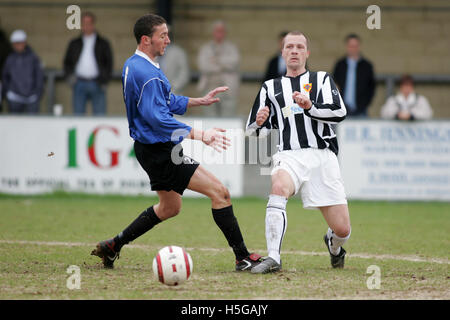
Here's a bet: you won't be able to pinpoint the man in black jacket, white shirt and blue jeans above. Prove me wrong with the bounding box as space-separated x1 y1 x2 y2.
64 12 113 115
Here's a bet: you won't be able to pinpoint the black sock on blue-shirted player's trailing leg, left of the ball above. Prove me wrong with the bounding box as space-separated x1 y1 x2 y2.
114 206 161 252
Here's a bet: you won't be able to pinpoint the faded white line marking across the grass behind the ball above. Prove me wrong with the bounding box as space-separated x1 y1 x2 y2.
0 239 450 264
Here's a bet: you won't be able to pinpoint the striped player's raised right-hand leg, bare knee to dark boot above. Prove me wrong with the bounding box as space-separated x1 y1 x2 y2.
320 204 351 268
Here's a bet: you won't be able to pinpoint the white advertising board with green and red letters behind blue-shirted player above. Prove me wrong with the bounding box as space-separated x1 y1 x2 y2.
0 116 244 196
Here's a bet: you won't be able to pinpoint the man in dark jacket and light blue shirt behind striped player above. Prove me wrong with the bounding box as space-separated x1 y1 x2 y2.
333 34 375 117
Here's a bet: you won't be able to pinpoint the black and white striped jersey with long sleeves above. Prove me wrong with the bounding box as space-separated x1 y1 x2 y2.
246 71 347 154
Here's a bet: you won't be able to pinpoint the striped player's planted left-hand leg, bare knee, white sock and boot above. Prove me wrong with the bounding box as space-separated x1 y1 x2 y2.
252 169 295 273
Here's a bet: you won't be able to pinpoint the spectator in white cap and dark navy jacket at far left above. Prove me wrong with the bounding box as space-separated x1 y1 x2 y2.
2 30 44 114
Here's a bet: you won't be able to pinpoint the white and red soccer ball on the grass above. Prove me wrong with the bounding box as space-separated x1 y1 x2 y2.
153 246 193 286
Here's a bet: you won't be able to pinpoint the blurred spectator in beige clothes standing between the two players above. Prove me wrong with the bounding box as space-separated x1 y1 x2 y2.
197 21 240 116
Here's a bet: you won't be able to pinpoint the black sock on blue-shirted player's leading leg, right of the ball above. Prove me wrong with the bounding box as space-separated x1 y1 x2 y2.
212 206 250 260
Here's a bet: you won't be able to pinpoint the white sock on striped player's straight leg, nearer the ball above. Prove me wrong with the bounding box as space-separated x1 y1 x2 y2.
266 194 287 263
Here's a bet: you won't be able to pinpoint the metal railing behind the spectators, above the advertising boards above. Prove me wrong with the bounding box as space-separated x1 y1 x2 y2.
45 69 450 113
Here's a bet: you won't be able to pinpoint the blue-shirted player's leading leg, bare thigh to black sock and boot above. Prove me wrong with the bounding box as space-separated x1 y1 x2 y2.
188 165 261 271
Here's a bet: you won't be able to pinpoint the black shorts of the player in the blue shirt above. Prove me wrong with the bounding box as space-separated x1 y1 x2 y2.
134 141 200 195
